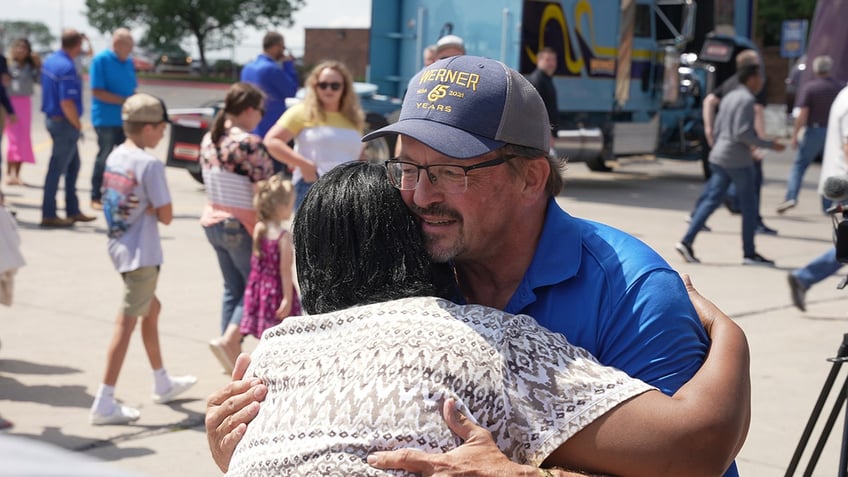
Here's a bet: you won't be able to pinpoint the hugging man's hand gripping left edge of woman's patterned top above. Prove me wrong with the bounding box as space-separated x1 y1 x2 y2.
206 353 268 472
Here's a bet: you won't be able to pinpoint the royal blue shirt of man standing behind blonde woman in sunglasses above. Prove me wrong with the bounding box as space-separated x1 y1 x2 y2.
241 53 299 137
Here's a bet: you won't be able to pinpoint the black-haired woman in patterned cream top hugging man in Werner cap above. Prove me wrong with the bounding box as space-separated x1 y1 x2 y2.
214 163 748 476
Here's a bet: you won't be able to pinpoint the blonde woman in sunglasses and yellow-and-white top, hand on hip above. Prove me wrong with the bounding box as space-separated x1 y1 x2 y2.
264 61 365 210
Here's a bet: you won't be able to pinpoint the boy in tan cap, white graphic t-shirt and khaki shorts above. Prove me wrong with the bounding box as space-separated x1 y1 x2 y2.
91 94 197 425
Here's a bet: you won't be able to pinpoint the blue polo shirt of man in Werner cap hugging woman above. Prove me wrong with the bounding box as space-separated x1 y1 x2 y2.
496 199 738 477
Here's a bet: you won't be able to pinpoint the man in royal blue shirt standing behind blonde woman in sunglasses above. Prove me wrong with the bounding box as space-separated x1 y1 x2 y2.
241 31 300 172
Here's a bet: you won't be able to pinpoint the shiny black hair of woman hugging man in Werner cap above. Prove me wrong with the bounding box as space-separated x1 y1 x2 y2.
292 161 453 314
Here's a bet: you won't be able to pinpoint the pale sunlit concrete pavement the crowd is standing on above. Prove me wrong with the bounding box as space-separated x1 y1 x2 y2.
0 80 848 477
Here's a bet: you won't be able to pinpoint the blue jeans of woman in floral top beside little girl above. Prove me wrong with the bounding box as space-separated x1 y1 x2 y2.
203 218 253 334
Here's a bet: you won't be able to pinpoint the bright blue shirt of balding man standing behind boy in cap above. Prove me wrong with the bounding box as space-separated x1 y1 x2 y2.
88 50 138 127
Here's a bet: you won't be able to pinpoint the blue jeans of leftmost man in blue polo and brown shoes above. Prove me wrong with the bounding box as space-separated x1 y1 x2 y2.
41 118 80 219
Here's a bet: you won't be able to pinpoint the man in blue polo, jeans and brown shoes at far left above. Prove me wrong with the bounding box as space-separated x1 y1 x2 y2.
41 29 96 227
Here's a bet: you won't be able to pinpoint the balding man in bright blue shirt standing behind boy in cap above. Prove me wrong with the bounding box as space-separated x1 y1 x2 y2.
88 28 138 210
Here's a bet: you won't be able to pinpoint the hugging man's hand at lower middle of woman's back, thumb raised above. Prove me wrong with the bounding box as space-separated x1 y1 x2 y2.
368 399 539 477
